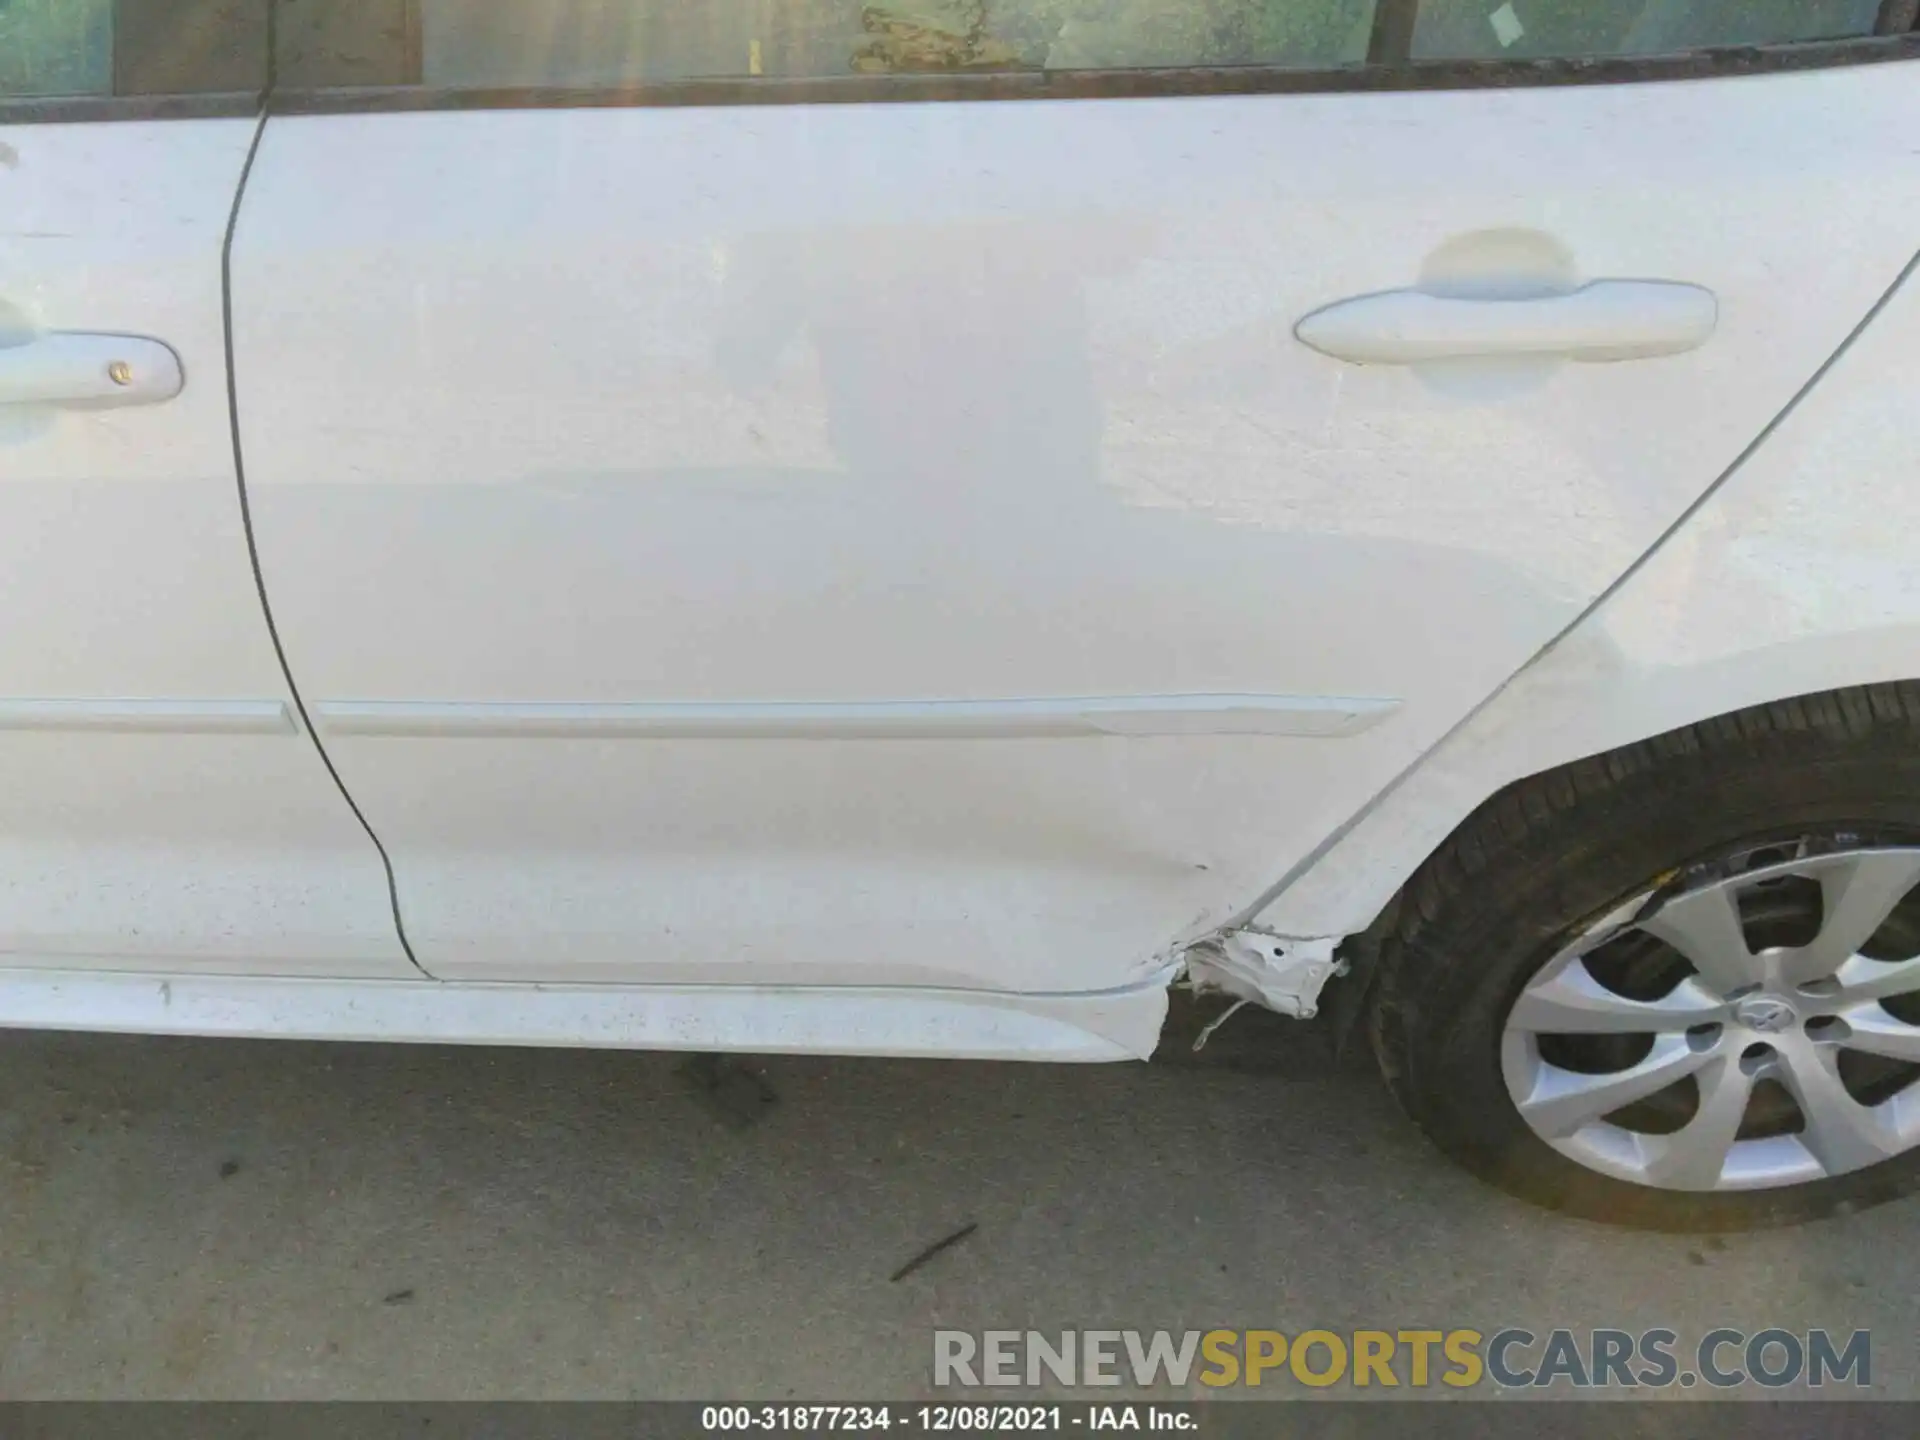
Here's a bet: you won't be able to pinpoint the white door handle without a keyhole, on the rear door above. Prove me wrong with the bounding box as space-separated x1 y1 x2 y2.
1294 280 1720 365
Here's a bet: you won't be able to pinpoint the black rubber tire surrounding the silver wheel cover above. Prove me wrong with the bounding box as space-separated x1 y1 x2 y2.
1369 682 1920 1231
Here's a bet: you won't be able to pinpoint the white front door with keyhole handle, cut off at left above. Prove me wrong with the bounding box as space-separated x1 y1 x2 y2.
0 0 419 977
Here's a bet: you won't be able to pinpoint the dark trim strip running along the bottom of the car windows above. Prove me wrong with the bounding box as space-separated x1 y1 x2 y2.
0 14 1920 125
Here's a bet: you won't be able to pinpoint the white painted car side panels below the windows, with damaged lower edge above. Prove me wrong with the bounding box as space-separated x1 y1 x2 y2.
0 11 1920 1060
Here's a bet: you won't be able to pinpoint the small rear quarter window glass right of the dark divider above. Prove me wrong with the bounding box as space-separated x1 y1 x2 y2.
1413 0 1880 60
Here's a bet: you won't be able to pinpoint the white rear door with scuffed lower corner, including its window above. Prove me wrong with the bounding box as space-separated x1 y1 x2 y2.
234 0 1920 991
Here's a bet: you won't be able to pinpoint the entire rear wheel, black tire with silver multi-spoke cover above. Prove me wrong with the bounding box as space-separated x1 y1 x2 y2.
1373 685 1920 1229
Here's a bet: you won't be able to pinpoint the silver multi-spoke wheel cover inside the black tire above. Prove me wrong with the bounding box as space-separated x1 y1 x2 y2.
1500 833 1920 1190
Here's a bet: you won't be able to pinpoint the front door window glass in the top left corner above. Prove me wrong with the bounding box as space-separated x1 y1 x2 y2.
0 0 271 98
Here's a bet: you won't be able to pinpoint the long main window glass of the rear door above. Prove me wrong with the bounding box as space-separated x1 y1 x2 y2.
408 0 1373 86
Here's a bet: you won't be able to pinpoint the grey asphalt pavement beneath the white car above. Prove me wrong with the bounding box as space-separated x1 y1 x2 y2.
0 1016 1920 1400
